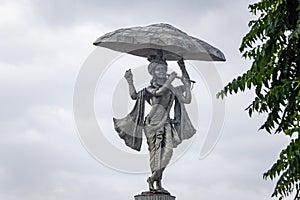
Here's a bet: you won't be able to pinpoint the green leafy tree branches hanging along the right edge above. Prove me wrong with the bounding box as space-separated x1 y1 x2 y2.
217 0 300 199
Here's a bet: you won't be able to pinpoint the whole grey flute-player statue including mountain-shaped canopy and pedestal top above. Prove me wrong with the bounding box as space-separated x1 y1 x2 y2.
93 23 225 197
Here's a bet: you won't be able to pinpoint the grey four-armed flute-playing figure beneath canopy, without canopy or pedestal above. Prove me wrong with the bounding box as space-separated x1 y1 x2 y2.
113 56 196 193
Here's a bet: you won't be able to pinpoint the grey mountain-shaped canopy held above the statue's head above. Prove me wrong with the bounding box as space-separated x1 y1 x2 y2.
93 23 226 61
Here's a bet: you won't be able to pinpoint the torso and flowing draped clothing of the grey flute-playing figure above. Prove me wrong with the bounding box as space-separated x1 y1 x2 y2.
113 85 196 178
